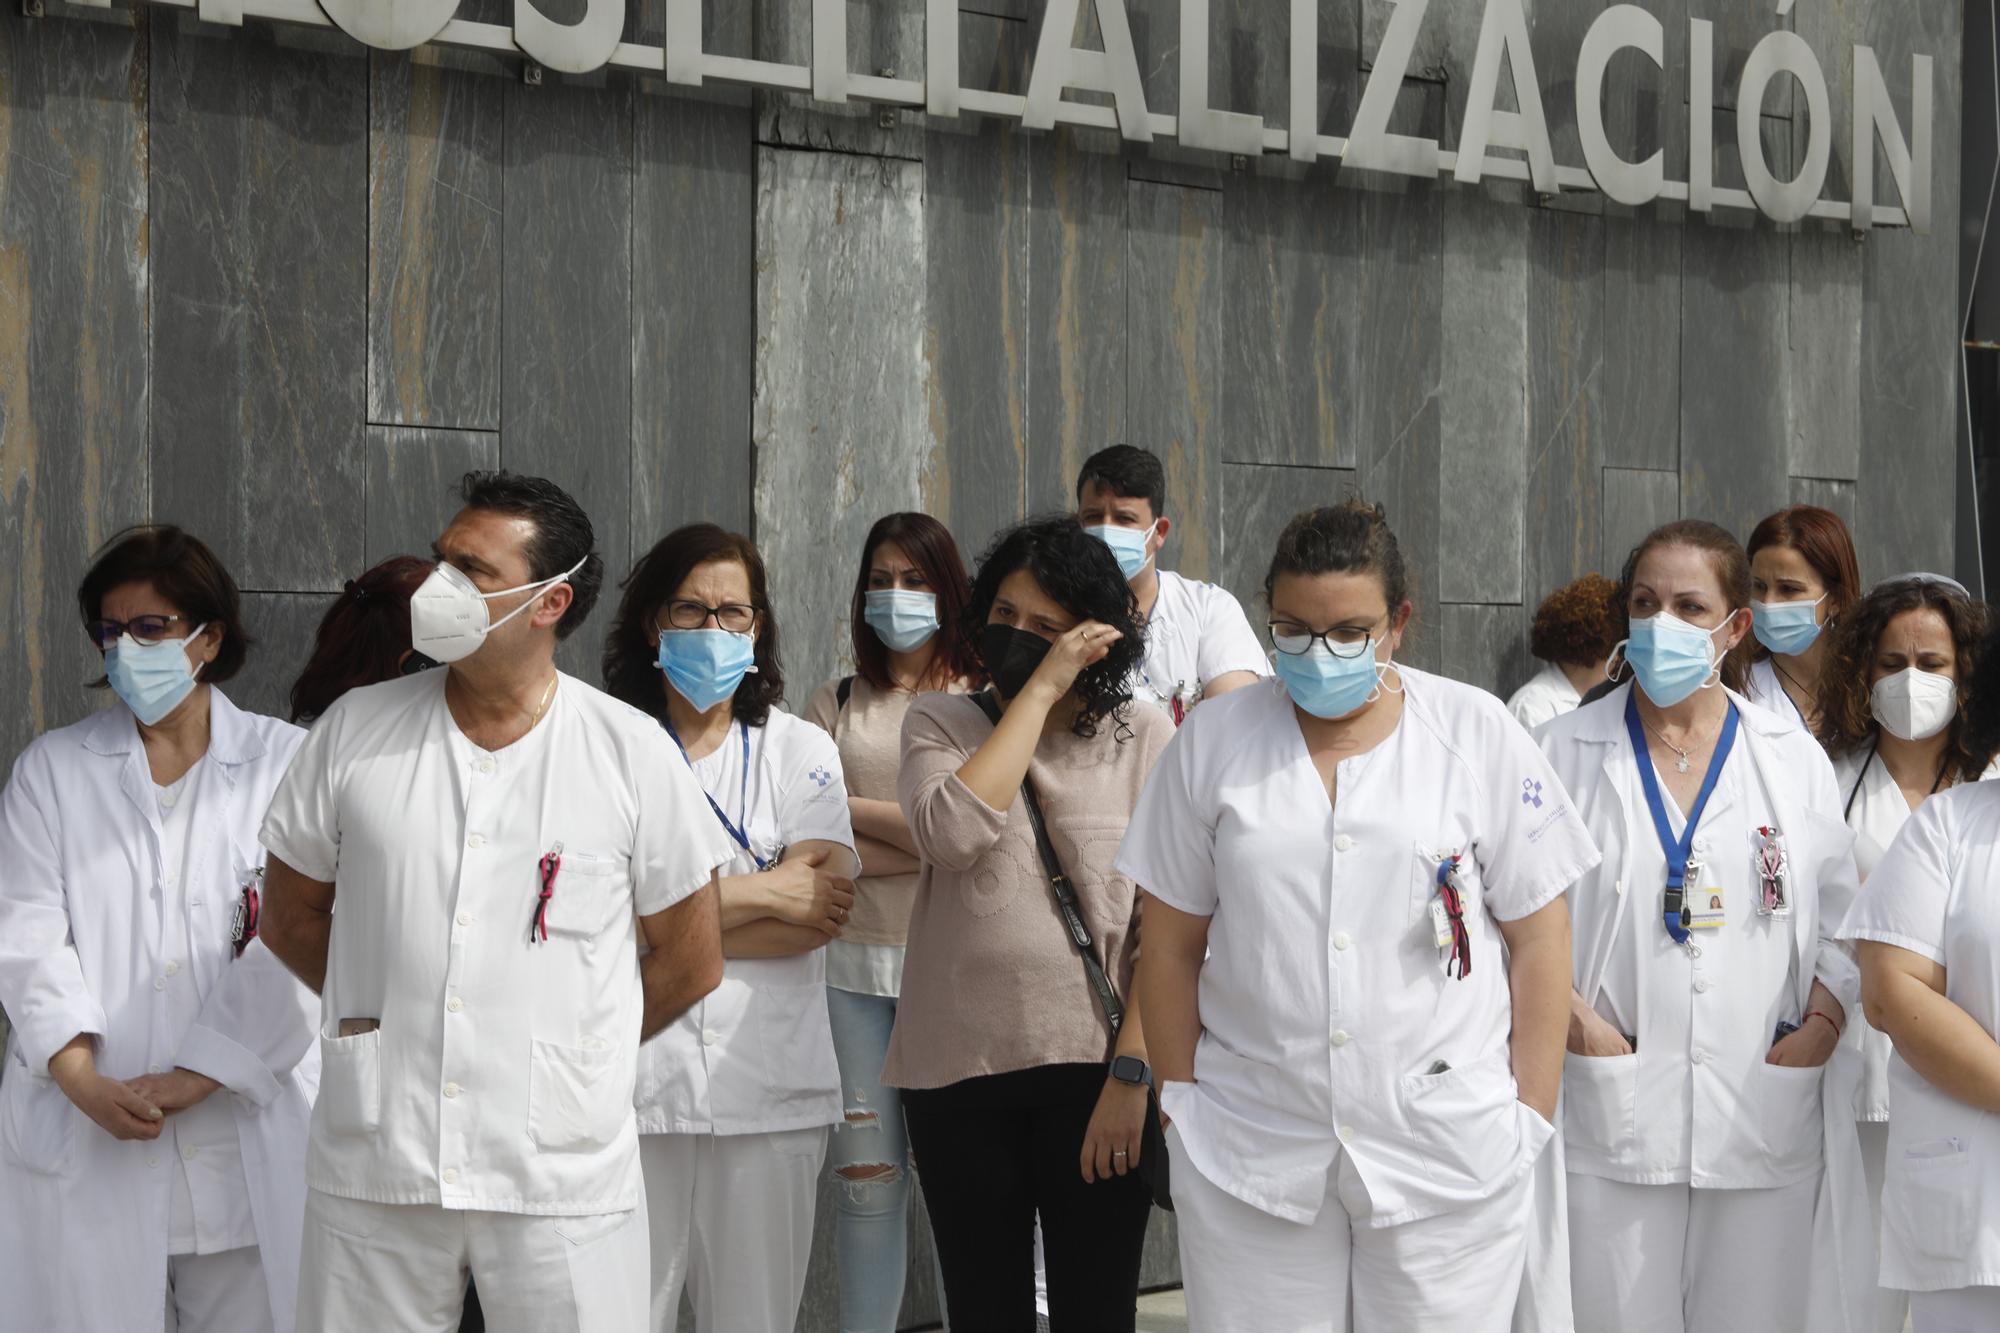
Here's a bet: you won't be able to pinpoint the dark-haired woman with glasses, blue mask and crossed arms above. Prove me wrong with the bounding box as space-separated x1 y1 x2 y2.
604 522 860 1333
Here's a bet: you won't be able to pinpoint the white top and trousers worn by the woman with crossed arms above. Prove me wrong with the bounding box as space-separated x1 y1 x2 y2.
638 713 860 1333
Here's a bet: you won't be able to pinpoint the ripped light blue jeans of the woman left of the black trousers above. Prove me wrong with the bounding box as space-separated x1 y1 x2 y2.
826 987 910 1333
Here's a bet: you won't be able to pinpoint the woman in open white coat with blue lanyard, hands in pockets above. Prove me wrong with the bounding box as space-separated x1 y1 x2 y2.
1536 518 1860 1333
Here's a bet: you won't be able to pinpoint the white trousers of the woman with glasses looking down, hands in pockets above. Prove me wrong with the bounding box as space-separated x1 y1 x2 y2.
1166 1129 1530 1333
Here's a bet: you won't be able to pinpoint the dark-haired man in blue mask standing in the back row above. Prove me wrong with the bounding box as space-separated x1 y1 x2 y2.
1076 444 1270 727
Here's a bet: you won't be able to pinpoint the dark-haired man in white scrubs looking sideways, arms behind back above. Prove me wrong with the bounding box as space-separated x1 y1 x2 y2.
262 472 730 1333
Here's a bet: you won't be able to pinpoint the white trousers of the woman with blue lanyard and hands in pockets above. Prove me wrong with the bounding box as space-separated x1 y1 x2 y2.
1570 1171 1820 1333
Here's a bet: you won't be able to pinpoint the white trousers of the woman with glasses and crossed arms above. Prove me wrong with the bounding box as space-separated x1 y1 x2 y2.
640 1127 828 1333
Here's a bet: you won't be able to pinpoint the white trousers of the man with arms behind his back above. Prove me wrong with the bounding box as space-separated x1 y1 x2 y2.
298 1189 646 1333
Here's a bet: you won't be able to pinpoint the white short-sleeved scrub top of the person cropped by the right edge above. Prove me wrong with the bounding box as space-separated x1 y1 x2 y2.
1840 783 2000 1291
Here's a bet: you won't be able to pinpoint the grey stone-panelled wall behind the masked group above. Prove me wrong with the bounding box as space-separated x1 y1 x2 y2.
0 0 1960 1329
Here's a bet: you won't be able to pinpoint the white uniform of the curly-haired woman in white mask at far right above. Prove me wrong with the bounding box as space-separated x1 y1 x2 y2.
1826 747 2000 1333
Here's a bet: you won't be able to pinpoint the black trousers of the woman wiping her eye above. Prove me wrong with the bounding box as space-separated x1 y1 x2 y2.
902 1065 1152 1333
